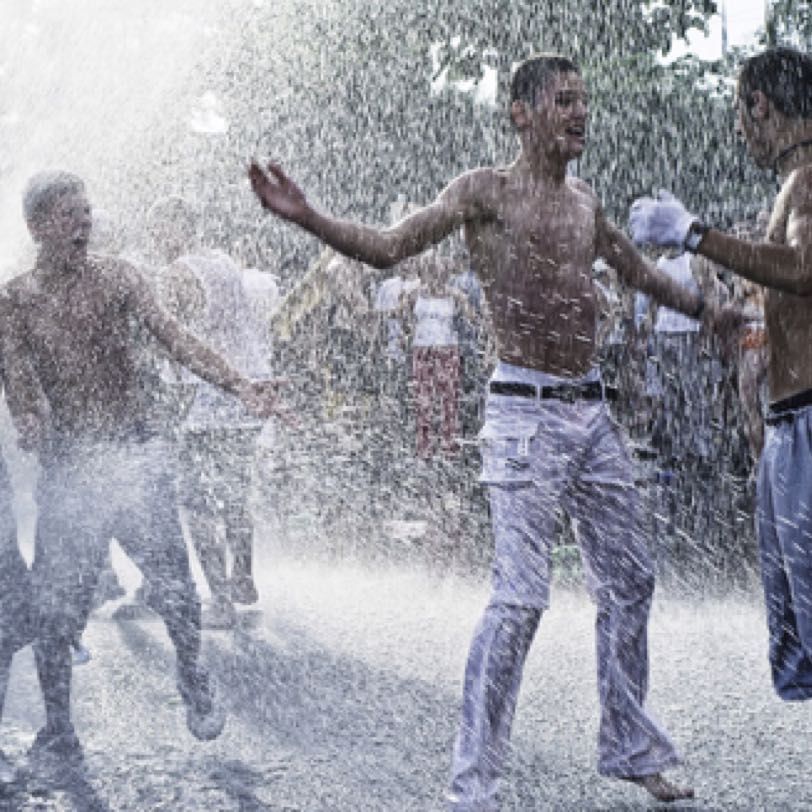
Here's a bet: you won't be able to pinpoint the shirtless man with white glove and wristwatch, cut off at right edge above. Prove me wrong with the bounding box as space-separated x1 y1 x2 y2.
630 48 812 700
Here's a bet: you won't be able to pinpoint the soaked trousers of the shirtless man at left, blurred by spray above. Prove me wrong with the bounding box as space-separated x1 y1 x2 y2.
31 439 200 731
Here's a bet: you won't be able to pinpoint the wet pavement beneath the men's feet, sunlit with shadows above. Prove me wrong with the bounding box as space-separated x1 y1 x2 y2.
0 548 812 812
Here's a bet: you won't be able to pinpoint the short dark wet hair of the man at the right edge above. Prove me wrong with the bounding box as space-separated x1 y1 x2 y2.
738 47 812 118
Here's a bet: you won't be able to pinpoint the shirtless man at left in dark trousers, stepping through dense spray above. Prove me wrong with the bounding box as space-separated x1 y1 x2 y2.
2 172 275 782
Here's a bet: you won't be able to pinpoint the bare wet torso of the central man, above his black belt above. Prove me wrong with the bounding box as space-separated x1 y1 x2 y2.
466 169 598 377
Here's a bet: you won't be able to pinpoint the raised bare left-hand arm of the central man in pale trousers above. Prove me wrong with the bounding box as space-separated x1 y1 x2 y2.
248 162 477 268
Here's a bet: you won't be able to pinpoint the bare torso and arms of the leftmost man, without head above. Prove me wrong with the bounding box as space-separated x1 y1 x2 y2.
0 255 251 442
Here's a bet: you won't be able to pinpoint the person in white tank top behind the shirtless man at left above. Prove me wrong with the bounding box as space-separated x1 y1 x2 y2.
158 200 273 628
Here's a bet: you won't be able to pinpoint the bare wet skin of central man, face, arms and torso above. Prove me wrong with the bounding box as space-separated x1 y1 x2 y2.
250 72 698 377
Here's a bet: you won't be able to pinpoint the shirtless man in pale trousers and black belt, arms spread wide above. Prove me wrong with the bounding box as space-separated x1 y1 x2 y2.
250 56 703 810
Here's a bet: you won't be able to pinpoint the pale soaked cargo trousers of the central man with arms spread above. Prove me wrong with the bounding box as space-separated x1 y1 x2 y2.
449 363 678 812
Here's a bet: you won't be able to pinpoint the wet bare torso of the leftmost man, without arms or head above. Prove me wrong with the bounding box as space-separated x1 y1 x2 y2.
8 255 157 442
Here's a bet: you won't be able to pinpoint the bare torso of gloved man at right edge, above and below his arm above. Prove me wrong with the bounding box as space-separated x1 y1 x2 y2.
764 166 812 402
